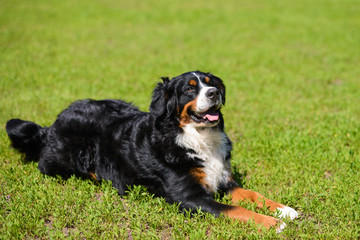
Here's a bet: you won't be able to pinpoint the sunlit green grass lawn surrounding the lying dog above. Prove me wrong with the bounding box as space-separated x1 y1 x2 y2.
0 0 360 239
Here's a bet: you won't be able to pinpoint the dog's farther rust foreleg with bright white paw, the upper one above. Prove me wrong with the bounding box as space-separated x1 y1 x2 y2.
230 187 299 220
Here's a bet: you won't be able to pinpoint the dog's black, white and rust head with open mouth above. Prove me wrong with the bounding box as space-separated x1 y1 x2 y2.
150 71 225 127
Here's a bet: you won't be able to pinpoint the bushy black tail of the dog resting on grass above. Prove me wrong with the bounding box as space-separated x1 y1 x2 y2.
6 119 46 161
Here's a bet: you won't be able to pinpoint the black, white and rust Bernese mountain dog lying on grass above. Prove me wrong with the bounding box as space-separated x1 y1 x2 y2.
6 71 298 232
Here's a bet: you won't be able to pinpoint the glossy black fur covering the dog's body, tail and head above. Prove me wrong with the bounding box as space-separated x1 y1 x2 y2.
6 72 237 215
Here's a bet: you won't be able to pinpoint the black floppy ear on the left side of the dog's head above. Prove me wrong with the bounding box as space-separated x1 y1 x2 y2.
149 77 177 127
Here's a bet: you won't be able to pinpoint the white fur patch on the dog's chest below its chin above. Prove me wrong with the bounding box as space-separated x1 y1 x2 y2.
177 124 231 193
